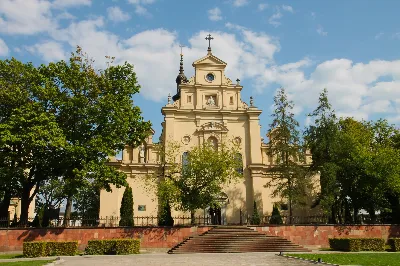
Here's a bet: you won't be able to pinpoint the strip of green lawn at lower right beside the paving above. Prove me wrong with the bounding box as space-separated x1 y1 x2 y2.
287 253 400 266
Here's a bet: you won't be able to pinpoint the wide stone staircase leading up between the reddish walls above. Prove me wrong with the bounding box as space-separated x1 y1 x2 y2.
168 226 310 254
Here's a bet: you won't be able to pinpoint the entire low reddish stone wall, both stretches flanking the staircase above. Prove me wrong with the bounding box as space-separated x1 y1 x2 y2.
0 225 400 252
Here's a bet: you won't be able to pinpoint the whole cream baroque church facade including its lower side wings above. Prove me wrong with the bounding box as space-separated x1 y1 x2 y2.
100 36 312 224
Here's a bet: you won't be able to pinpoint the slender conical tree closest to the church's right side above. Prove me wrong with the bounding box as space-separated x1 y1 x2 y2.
265 88 311 222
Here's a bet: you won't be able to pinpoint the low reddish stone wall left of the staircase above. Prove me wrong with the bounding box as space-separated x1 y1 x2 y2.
0 227 209 252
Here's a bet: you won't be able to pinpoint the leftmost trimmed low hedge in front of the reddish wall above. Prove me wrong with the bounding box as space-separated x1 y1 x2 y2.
23 241 78 258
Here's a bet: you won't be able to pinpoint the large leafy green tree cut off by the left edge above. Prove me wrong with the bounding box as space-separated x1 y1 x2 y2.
0 58 66 223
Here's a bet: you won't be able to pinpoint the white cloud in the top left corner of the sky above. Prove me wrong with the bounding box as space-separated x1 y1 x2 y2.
0 0 56 35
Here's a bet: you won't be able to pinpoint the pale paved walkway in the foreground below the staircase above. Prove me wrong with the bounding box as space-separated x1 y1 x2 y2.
59 253 318 266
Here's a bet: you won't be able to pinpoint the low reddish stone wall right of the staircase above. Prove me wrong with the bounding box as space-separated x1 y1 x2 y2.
252 225 400 247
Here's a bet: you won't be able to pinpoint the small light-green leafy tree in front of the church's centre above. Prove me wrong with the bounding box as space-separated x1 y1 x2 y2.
174 143 242 224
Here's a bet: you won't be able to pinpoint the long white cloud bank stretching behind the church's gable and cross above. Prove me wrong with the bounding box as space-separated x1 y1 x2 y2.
28 18 400 120
